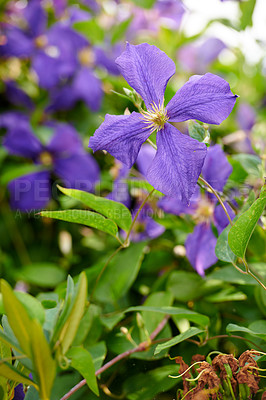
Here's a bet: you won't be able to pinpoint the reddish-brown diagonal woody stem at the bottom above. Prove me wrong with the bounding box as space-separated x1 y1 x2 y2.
60 315 169 400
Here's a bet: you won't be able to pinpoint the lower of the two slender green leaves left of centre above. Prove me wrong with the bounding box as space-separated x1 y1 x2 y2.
40 210 118 237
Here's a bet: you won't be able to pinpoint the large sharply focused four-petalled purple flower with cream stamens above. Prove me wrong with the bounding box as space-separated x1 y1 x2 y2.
90 43 237 203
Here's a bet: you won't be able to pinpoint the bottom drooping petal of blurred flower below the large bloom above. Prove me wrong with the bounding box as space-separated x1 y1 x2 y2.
185 224 217 276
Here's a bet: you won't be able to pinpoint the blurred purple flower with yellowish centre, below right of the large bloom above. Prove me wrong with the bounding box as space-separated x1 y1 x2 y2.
158 144 234 276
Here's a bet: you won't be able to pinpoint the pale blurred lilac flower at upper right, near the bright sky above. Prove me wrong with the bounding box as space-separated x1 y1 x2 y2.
178 38 226 74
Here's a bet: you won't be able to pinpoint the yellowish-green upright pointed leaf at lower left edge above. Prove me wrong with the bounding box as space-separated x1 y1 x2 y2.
1 279 32 357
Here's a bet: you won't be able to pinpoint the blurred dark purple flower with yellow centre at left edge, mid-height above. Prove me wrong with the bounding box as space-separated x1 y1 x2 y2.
0 113 99 211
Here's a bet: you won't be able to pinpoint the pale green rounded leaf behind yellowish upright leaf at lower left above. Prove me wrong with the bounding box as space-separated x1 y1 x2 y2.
0 291 45 324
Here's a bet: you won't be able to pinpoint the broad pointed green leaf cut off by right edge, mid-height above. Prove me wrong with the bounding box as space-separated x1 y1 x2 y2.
228 185 266 258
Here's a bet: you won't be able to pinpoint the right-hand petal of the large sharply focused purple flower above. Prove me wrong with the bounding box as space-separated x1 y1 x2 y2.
166 73 237 124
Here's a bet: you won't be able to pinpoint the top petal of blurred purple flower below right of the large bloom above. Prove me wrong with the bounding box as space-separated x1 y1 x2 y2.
202 144 233 192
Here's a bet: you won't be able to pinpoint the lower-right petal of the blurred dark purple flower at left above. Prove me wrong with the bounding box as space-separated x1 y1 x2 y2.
54 153 100 192
